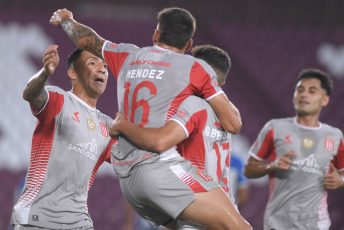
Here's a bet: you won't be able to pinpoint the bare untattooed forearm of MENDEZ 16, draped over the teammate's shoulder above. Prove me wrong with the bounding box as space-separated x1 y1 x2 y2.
208 93 242 134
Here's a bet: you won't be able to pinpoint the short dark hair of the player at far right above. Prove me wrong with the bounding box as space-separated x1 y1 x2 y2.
296 69 333 96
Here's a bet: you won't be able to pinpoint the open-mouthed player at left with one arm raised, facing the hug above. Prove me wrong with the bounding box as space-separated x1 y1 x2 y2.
11 45 114 230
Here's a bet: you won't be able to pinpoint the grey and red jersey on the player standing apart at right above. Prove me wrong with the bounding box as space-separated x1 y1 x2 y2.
249 117 344 229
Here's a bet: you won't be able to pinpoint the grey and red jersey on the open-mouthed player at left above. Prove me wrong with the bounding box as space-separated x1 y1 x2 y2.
11 86 113 229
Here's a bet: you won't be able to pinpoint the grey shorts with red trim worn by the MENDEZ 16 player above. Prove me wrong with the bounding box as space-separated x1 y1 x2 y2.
119 156 220 227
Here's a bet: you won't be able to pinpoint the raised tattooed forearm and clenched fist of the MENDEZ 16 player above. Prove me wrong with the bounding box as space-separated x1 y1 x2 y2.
50 9 105 58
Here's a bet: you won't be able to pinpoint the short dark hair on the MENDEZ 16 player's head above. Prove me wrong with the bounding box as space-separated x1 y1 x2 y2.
158 7 196 49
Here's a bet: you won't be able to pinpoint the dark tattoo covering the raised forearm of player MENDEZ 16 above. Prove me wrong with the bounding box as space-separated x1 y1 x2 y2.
61 18 105 58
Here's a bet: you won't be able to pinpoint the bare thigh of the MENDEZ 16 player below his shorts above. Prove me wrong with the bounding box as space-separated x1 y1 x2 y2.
180 188 252 230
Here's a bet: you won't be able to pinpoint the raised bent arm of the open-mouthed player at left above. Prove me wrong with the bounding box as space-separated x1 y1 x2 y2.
23 45 60 110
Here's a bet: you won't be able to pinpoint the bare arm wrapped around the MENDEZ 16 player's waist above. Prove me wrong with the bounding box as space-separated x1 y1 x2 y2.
110 112 186 153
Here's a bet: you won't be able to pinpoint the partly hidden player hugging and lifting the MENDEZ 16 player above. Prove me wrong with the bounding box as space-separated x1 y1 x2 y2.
110 45 251 229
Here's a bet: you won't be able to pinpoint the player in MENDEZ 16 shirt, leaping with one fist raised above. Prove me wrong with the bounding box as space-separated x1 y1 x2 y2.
50 8 249 229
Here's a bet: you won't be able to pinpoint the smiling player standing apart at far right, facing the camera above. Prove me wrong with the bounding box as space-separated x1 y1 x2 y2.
245 69 344 230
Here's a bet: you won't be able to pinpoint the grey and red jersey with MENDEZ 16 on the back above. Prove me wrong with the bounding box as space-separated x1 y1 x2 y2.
103 42 221 178
